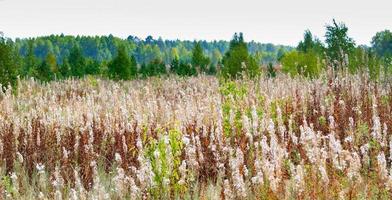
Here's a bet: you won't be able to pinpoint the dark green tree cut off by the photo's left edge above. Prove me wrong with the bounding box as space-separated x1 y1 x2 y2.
0 37 20 89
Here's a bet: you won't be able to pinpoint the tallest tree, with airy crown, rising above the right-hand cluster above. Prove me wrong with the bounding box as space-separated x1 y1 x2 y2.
325 19 355 68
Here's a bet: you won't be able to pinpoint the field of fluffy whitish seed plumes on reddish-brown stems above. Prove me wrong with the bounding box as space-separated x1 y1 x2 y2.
0 75 392 199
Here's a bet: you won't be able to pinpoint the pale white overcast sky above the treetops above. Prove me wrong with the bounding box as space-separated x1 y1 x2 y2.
0 0 392 46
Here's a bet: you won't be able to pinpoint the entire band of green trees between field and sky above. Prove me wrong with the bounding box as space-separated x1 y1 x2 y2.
0 20 392 89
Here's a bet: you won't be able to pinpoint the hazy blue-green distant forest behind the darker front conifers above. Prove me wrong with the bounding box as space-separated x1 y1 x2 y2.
16 34 291 65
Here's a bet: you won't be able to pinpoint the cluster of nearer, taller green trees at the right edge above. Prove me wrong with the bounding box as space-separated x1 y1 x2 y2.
278 20 392 79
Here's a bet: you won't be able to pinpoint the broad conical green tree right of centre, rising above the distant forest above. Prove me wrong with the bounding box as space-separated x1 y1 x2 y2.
222 33 260 78
